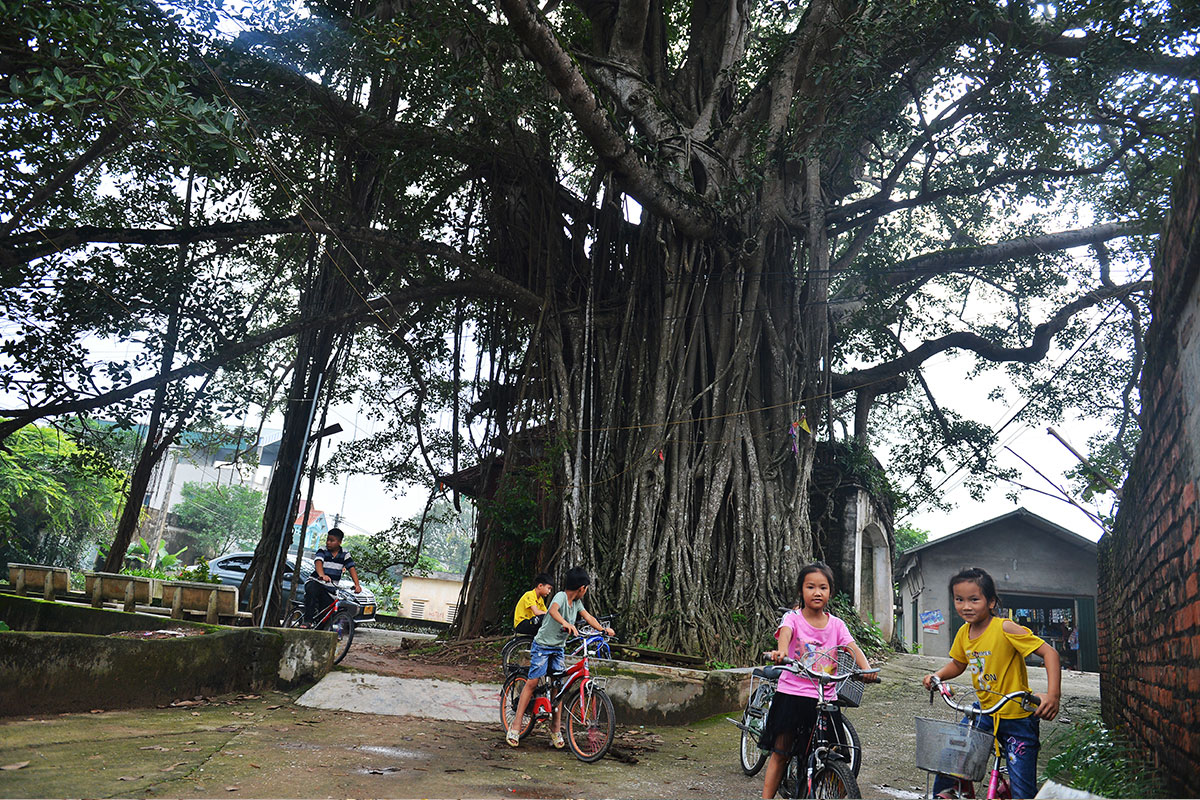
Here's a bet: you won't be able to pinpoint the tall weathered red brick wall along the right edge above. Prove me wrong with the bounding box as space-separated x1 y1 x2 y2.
1098 115 1200 796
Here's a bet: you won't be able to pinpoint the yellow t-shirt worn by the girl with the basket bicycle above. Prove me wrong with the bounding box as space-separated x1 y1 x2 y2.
950 616 1044 720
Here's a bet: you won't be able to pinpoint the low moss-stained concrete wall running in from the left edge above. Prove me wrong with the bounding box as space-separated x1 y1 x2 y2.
0 594 336 716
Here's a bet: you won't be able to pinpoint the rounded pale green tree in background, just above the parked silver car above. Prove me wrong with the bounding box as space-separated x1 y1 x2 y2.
174 481 266 558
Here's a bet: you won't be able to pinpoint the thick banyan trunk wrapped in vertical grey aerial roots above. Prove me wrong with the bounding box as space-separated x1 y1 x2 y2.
550 223 823 657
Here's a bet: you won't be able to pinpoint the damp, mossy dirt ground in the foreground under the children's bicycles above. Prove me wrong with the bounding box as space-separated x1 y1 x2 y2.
0 656 1099 798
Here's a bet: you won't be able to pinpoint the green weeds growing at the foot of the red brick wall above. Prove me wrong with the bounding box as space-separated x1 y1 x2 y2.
1042 716 1170 798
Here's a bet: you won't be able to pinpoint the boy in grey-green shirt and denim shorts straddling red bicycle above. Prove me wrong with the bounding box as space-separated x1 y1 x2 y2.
504 566 613 750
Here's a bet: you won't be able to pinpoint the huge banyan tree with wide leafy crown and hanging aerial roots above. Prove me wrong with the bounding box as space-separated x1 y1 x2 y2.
0 0 1200 654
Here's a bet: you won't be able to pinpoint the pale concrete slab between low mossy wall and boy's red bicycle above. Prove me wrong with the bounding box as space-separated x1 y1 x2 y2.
296 672 500 722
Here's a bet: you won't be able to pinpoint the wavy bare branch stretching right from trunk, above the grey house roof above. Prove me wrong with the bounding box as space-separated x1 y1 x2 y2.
832 281 1151 397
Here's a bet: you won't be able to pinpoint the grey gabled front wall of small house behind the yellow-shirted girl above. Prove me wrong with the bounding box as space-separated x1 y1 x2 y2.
900 517 1097 656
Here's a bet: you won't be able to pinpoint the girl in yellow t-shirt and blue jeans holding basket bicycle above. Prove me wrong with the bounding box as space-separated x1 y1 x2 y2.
923 567 1062 798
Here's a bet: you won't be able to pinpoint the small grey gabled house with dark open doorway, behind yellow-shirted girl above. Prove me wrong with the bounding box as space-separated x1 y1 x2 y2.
895 509 1099 672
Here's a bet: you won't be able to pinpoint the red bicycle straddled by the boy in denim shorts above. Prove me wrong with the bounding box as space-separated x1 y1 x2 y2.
500 650 617 764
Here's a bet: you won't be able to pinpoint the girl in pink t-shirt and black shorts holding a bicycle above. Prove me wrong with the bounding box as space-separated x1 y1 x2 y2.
758 561 878 800
